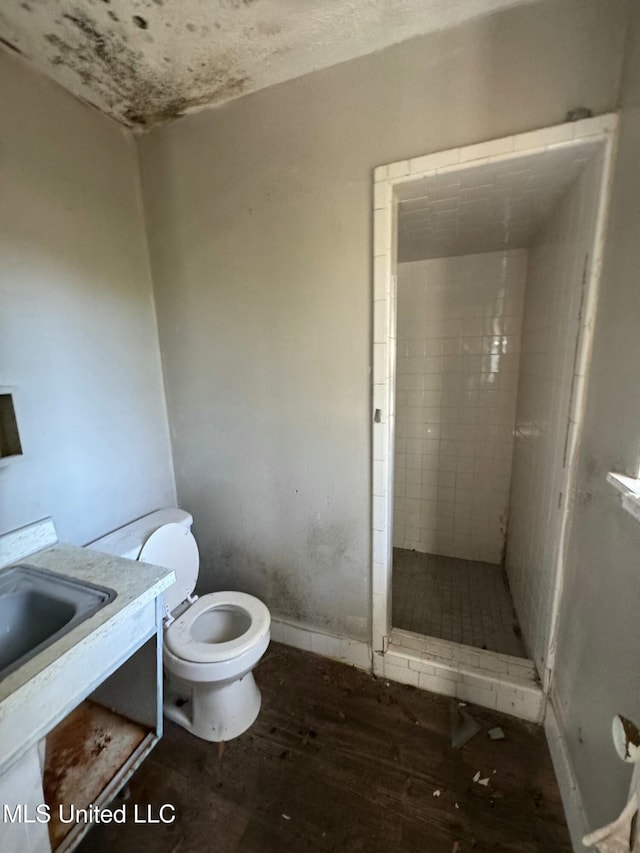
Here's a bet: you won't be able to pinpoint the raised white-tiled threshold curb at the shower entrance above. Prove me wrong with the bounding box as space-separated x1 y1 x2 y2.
383 628 545 723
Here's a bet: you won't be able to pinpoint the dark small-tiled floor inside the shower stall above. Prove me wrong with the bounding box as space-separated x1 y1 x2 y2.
393 548 527 658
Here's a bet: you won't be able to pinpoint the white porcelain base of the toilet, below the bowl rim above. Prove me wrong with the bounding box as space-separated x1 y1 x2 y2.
163 671 262 742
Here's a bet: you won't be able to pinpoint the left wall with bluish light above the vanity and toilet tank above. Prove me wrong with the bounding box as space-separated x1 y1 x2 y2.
0 51 175 544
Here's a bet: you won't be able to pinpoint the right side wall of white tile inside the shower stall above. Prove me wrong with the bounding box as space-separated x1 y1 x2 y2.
506 154 602 673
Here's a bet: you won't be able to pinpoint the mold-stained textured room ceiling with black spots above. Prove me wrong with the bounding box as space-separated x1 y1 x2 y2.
0 0 523 127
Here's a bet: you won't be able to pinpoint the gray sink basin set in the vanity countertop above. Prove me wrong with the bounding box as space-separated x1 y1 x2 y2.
0 565 116 680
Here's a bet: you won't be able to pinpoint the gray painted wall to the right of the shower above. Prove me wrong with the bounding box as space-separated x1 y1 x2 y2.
552 4 640 828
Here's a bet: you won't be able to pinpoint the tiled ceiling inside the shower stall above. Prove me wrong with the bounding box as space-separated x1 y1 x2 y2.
398 142 599 262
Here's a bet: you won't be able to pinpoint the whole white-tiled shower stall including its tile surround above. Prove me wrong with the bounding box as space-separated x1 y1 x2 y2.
374 116 615 705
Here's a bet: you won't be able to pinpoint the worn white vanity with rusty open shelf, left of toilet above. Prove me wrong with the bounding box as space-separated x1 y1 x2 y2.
0 519 174 853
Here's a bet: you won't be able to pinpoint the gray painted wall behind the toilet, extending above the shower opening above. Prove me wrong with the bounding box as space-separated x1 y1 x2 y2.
139 0 626 640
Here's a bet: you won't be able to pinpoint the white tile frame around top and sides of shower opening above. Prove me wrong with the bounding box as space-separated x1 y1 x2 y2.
371 113 618 694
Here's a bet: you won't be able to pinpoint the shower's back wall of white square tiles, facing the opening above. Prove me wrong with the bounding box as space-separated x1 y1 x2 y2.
393 250 527 563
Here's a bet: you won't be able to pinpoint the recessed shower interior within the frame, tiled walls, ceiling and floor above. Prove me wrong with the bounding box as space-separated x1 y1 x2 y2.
393 150 601 666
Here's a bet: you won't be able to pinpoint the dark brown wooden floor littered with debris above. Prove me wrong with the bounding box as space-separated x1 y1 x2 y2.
80 643 571 853
